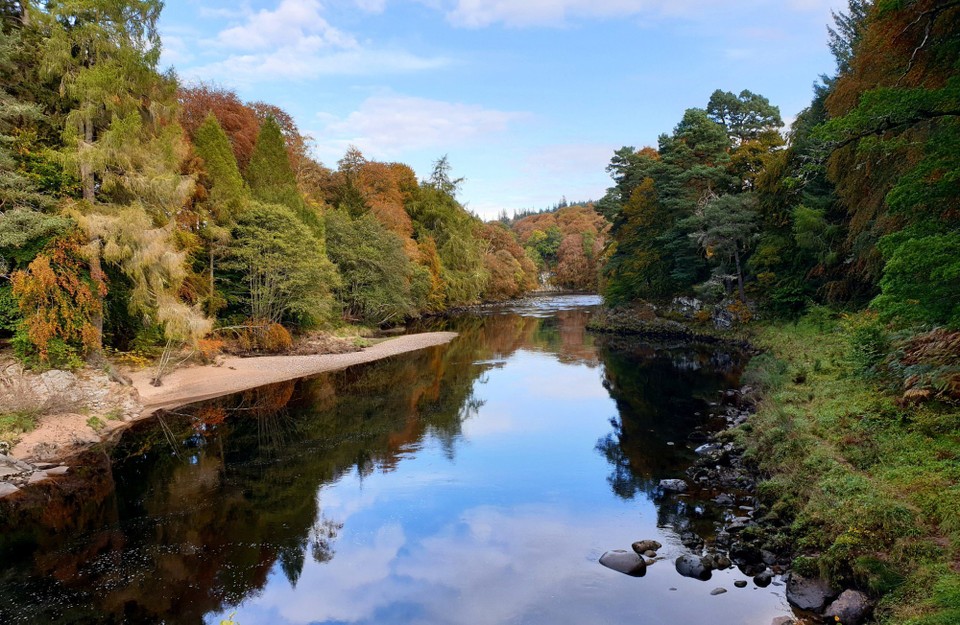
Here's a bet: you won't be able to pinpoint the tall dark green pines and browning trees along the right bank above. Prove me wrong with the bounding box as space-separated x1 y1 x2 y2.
597 0 960 328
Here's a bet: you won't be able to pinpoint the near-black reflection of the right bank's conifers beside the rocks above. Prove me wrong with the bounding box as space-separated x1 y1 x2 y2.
597 337 744 499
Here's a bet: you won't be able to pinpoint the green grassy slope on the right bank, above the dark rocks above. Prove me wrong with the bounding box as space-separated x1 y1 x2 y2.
736 316 960 625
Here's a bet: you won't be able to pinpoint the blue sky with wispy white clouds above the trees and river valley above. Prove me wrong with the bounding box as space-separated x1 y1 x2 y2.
161 0 846 218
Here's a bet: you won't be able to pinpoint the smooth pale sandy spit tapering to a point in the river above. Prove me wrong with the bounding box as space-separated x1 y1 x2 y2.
131 332 457 415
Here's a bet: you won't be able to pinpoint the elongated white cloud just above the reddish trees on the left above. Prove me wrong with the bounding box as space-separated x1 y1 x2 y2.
318 95 527 158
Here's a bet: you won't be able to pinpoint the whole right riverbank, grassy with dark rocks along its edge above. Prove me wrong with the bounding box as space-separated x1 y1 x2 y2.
591 306 960 625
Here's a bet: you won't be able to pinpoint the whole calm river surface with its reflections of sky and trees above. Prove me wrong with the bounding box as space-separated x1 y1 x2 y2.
0 296 790 625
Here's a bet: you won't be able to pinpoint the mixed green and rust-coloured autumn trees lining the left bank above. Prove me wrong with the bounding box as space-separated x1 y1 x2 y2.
0 0 537 366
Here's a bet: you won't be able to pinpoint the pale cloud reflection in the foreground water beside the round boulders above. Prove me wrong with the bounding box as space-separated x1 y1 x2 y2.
223 506 785 625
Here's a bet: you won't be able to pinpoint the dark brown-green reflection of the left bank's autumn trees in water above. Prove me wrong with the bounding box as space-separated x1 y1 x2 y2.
0 331 506 623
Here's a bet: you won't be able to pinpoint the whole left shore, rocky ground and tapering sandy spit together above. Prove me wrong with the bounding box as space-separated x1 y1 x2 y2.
0 332 457 482
